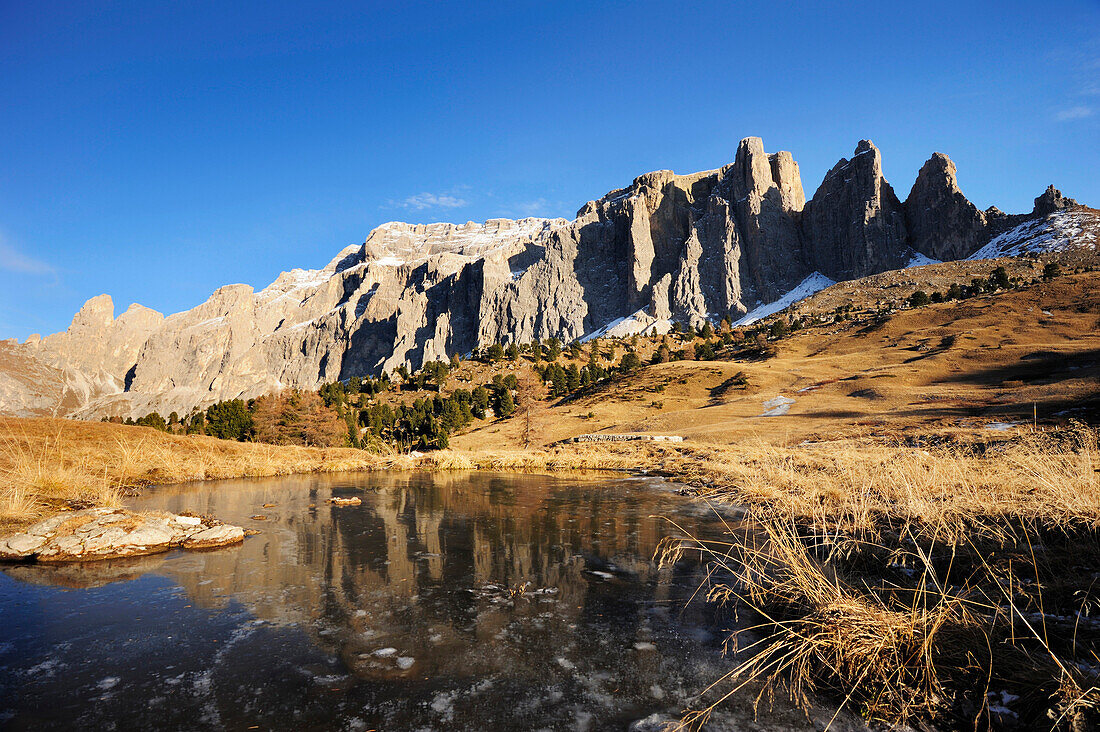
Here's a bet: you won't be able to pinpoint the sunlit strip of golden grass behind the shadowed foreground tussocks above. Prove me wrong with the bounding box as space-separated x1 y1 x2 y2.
525 426 1100 538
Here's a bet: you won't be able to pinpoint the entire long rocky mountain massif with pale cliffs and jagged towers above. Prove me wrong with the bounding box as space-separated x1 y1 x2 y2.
0 138 1089 417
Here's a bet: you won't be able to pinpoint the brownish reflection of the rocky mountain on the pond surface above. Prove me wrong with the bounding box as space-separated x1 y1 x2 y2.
128 473 726 678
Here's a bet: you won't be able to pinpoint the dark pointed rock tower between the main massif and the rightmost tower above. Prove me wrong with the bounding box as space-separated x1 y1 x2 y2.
802 140 909 280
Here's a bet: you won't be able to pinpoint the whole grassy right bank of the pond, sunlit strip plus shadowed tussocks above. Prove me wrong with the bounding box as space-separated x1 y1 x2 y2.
649 425 1100 730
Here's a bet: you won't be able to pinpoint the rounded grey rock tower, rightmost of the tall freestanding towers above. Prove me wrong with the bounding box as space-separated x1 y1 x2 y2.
905 153 988 260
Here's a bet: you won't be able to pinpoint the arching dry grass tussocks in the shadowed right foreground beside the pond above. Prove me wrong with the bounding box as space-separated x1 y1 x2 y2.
659 518 1100 730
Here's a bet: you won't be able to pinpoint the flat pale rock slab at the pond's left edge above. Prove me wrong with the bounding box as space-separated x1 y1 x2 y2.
0 509 244 562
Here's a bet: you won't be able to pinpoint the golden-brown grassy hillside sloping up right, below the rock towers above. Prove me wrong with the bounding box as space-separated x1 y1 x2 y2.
451 263 1100 450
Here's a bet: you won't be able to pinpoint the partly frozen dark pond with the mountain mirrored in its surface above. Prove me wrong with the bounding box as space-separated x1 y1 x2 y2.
0 473 796 730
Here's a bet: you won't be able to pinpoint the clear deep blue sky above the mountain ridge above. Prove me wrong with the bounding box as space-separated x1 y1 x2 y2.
0 0 1100 339
